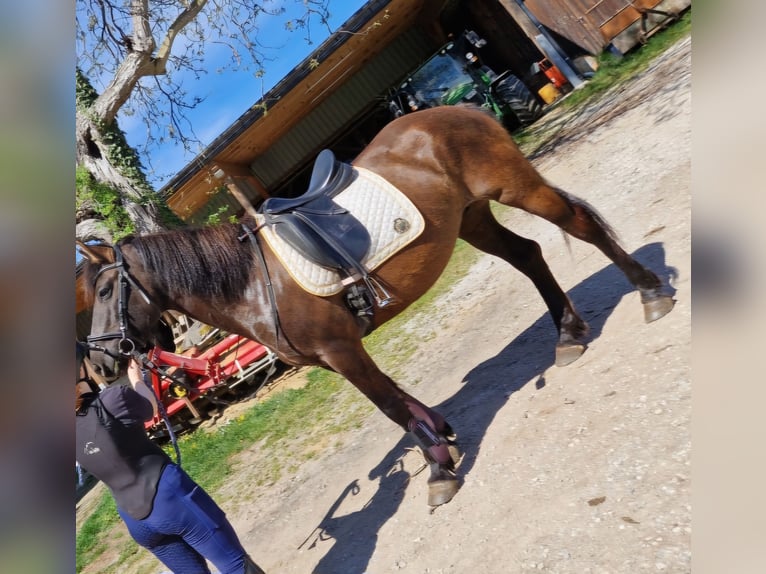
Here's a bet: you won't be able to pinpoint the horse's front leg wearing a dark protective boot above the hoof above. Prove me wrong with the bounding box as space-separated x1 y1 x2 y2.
324 342 460 506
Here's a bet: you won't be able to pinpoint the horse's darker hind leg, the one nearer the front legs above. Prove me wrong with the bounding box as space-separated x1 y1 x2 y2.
460 201 588 367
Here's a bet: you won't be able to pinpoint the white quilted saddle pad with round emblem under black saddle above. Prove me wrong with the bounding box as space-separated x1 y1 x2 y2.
257 167 425 297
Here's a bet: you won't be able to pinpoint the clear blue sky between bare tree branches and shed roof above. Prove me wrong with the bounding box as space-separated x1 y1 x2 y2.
118 0 366 189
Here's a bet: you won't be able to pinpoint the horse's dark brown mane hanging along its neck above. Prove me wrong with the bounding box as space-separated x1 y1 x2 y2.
120 223 253 301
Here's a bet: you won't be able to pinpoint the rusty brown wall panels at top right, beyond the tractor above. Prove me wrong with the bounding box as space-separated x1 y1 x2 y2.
525 0 661 54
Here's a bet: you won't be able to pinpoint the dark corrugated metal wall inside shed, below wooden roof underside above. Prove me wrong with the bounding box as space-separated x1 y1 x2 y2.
251 29 435 189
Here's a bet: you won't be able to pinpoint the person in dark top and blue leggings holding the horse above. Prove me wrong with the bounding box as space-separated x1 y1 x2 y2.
75 341 265 574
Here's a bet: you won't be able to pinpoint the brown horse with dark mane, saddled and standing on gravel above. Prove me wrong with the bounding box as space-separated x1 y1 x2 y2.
81 107 675 506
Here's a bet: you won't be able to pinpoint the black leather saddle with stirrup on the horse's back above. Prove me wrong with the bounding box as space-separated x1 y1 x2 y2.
259 149 391 314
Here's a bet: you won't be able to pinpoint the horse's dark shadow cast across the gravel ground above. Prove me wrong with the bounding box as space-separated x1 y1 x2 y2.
302 243 676 574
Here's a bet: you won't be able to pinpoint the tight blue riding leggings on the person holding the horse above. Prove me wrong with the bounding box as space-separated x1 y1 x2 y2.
117 463 246 574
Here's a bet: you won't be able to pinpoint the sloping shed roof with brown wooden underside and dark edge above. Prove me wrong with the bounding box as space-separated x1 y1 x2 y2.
160 0 444 217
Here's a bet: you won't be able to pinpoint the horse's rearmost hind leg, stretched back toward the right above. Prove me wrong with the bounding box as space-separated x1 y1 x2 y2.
500 184 675 323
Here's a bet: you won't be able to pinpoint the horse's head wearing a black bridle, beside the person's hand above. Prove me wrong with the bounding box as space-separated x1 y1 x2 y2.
78 242 166 379
